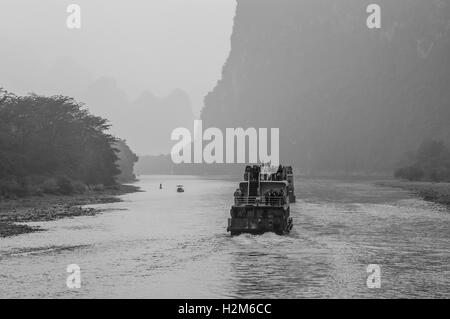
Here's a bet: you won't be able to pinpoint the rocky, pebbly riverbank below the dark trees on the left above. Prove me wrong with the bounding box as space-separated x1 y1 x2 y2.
0 185 140 238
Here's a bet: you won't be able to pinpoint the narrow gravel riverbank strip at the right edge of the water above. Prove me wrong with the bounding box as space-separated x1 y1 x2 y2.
377 181 450 208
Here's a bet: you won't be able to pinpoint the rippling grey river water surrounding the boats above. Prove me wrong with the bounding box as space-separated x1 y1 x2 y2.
0 176 450 298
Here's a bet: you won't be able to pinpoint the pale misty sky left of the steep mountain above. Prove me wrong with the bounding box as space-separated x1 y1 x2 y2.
0 0 236 113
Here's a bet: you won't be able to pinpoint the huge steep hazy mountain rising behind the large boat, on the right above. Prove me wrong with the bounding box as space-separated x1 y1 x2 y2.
202 0 450 173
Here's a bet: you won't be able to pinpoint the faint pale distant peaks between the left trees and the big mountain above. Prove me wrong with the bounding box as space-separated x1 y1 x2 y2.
83 78 194 155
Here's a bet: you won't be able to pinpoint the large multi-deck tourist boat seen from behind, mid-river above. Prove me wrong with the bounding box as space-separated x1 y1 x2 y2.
227 164 295 236
